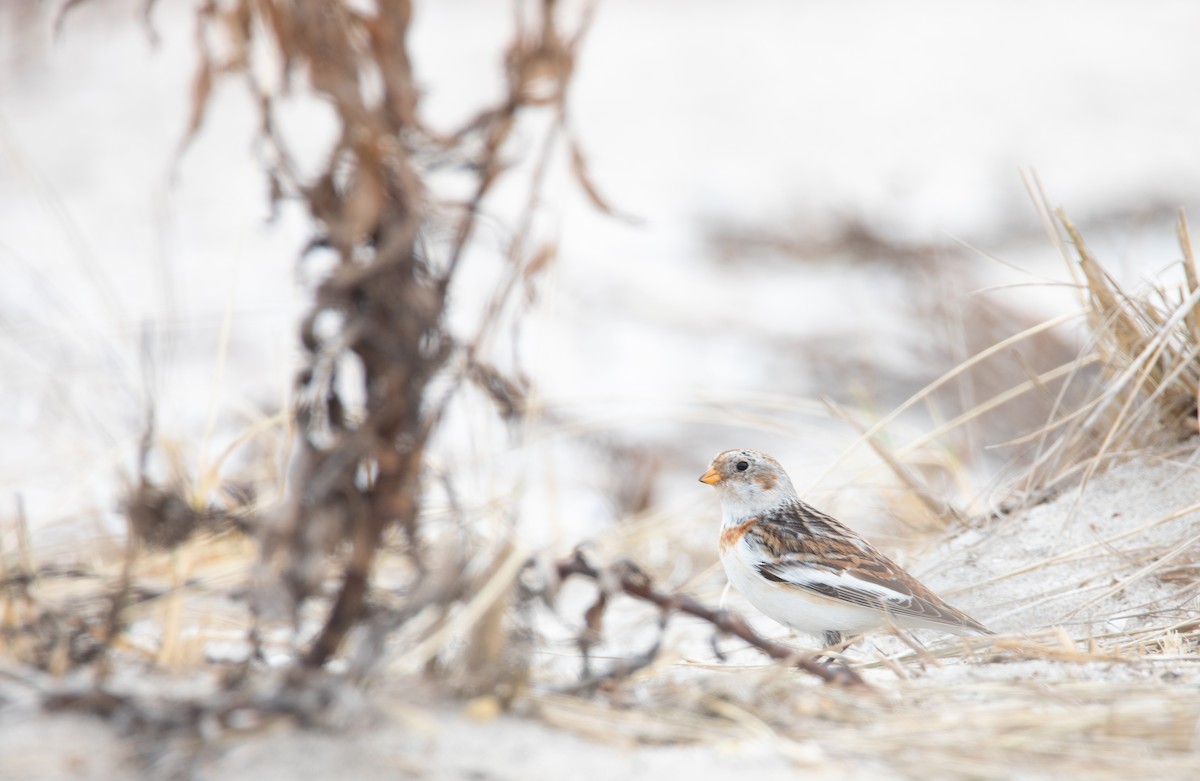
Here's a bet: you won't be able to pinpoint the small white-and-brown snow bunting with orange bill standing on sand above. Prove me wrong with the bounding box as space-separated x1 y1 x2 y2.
700 450 991 645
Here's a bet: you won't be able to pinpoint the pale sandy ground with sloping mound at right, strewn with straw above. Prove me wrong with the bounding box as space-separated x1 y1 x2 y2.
0 453 1200 781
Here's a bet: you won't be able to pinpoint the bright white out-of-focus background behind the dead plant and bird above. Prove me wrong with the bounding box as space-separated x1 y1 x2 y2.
0 0 1200 547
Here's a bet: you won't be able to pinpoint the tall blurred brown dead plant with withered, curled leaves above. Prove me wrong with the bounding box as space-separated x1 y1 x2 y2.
188 0 606 683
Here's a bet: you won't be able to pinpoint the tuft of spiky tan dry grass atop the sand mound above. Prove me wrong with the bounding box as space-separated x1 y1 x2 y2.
801 196 1200 537
